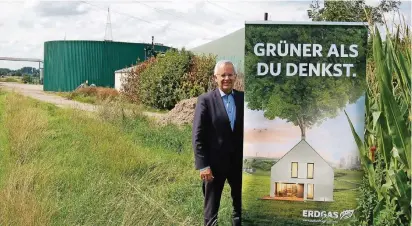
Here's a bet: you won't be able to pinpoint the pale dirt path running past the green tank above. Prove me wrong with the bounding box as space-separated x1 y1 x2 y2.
0 82 163 118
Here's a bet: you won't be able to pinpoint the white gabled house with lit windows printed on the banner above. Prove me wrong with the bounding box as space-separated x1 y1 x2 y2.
270 139 334 201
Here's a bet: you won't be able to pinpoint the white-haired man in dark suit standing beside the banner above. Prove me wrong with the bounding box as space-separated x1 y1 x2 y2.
192 61 244 226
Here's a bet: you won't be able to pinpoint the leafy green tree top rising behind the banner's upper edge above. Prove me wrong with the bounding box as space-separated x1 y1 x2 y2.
308 0 401 23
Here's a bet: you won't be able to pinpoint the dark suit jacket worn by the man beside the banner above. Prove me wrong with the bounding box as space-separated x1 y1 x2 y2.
192 88 244 173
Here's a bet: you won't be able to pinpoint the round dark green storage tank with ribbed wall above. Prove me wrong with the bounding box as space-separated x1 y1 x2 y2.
43 41 170 92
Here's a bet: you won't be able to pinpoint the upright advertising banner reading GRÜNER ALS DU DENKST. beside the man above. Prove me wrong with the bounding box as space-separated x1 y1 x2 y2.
242 21 368 226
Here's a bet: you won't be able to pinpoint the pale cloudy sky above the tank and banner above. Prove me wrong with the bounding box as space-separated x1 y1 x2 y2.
0 0 411 69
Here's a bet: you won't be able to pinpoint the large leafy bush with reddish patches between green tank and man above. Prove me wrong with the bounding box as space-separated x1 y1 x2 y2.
133 49 216 110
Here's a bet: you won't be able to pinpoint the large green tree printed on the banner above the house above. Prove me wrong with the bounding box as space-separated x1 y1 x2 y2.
245 25 367 139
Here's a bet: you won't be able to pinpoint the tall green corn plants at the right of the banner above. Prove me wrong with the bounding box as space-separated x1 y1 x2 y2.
348 22 412 225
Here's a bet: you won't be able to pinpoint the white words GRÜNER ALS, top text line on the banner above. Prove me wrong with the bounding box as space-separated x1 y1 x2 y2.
253 40 358 57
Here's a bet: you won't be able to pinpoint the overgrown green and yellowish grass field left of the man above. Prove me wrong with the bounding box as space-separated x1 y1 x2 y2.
0 93 232 225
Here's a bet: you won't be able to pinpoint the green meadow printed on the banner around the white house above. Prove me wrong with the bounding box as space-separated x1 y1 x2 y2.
243 170 362 225
